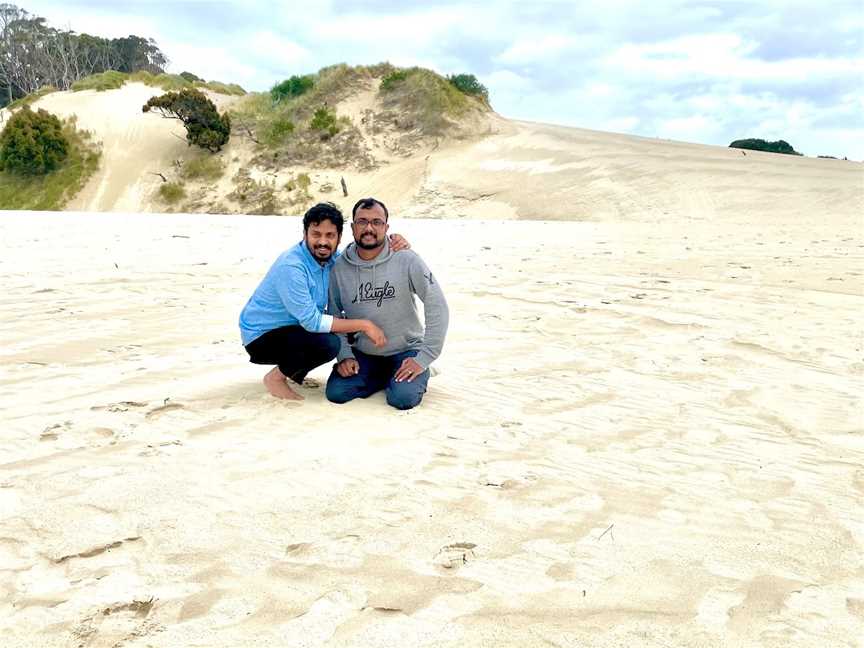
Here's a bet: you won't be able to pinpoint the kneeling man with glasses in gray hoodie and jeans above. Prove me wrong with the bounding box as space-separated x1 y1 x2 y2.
326 198 449 410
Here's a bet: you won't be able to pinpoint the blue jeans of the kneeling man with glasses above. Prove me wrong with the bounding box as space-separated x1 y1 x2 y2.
326 349 429 410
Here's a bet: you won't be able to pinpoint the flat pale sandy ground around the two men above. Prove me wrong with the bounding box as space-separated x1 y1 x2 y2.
0 209 864 648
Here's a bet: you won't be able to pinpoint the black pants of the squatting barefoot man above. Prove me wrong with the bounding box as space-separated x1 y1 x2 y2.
246 326 339 385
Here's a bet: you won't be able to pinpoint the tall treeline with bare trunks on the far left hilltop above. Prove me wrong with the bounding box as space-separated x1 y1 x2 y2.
0 3 168 107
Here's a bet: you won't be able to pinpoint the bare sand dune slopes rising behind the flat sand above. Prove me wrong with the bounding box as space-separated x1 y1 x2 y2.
10 83 864 224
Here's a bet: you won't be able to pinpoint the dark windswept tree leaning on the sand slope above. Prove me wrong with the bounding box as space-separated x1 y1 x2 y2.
142 88 231 153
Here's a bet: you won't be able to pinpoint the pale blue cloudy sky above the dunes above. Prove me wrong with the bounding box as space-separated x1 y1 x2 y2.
17 0 864 160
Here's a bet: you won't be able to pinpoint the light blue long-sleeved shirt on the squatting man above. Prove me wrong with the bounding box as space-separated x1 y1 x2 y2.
240 241 339 346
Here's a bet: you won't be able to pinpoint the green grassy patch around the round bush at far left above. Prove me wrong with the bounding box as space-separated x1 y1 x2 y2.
0 117 101 210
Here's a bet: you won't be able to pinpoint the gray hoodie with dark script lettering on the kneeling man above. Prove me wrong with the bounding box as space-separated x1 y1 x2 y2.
329 242 450 369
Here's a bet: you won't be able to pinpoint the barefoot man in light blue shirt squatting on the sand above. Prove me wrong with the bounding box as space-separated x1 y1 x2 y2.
240 203 409 400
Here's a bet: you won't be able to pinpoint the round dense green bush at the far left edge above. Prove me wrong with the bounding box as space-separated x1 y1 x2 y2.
0 106 69 175
